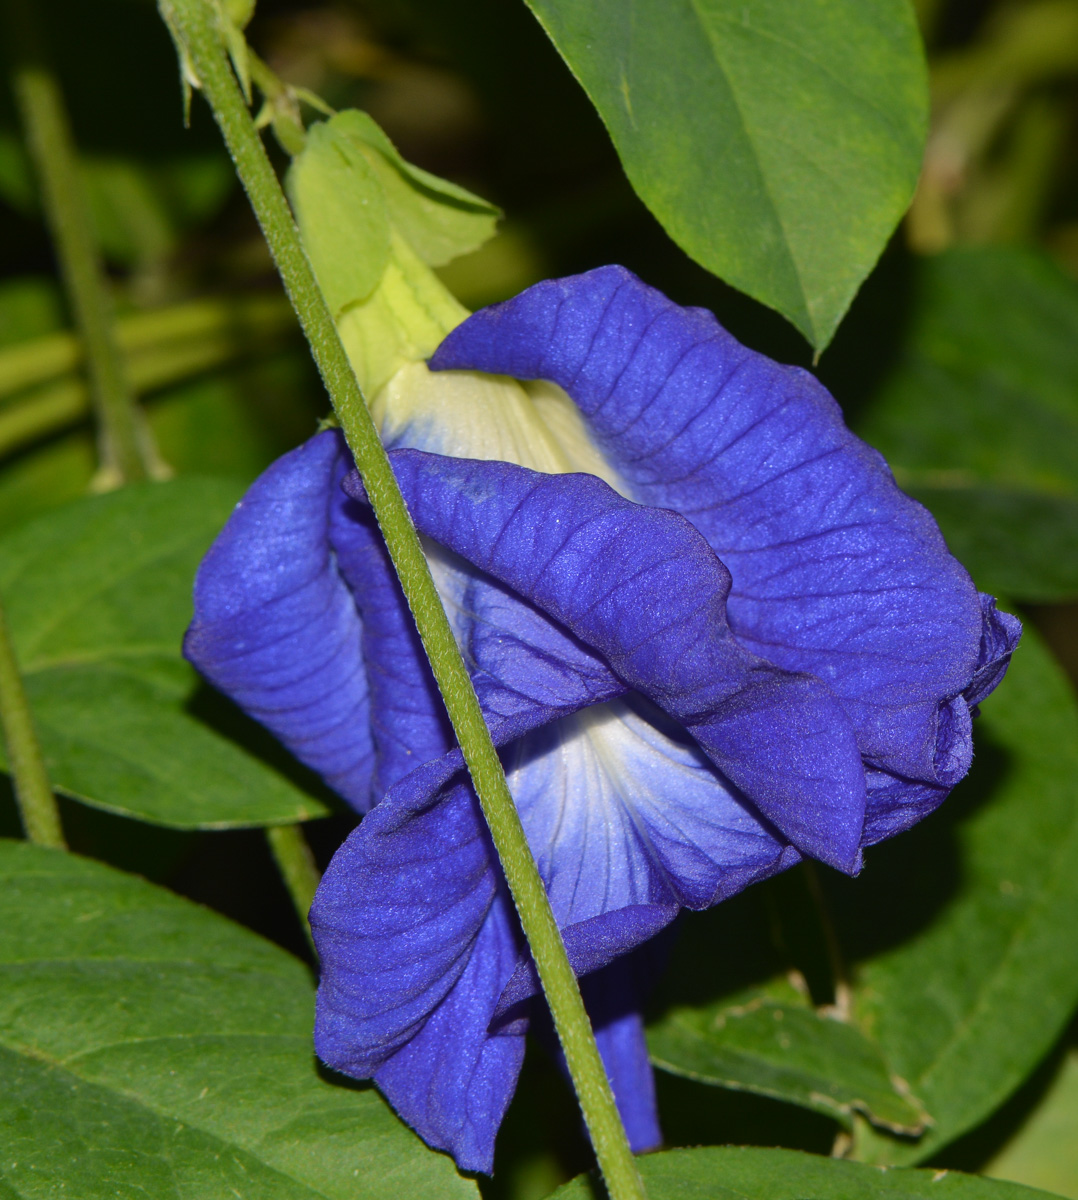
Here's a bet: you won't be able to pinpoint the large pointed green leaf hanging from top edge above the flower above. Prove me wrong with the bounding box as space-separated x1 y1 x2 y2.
528 0 928 350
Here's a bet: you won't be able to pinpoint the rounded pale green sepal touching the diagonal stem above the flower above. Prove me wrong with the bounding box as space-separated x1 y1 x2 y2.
288 118 390 320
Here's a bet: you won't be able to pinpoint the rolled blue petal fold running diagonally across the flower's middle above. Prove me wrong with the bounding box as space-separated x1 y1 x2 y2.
360 450 864 871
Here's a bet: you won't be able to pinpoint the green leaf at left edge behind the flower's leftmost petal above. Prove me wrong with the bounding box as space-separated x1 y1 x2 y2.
0 479 328 829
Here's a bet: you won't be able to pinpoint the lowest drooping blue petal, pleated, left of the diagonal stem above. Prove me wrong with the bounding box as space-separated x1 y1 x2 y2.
311 704 673 1171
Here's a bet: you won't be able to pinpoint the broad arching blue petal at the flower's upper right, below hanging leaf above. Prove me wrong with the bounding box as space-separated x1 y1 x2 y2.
431 268 982 784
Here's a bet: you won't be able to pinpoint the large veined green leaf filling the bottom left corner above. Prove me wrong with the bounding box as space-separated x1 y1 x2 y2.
0 841 477 1200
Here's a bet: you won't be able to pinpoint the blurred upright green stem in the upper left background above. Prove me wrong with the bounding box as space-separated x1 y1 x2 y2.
7 0 150 481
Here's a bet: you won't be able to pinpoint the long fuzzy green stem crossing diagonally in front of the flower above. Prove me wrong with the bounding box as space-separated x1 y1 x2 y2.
158 0 645 1200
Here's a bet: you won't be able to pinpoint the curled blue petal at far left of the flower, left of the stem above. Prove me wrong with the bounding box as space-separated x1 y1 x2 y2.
184 432 373 811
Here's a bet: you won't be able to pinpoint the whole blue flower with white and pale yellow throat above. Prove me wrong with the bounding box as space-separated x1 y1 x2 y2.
186 268 1019 1171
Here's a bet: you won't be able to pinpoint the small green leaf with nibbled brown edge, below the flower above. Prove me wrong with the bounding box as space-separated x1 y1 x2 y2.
648 994 927 1134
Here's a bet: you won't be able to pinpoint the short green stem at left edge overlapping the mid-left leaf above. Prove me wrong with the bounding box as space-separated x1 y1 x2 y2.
0 595 66 850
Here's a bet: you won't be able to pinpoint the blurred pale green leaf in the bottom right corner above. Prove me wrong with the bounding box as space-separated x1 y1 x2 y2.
984 1050 1078 1200
